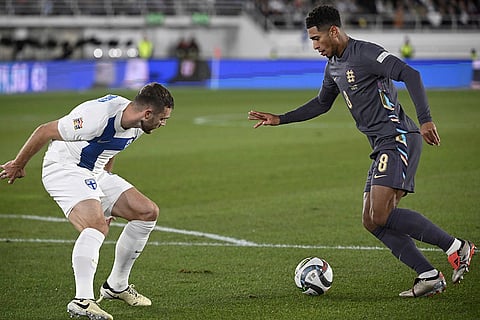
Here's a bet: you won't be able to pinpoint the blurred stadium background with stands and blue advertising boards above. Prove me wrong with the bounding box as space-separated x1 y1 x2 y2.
0 0 480 93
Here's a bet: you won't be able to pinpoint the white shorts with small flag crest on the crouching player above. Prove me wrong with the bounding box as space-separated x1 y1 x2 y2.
42 161 133 217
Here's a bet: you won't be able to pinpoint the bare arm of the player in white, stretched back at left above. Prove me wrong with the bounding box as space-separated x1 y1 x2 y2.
0 120 62 184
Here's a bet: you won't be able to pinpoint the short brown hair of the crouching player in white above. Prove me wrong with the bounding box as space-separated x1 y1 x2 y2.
134 82 175 112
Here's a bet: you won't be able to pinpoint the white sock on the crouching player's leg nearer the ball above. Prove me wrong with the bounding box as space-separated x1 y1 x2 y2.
107 220 156 292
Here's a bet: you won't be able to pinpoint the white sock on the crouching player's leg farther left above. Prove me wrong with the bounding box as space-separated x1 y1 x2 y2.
72 228 105 299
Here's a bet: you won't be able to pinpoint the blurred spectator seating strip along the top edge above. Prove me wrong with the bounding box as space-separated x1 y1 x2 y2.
0 0 480 29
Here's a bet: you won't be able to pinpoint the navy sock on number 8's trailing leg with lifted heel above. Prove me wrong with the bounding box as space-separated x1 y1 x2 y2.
385 208 455 252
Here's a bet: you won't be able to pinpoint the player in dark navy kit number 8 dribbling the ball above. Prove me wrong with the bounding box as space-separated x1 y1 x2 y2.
249 6 475 297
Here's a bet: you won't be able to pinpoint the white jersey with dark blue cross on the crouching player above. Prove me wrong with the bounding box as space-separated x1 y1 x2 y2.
45 95 143 174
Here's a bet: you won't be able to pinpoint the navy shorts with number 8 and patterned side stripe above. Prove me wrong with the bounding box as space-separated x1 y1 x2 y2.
364 133 423 193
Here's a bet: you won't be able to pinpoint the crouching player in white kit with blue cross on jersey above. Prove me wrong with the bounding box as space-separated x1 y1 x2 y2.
0 83 174 320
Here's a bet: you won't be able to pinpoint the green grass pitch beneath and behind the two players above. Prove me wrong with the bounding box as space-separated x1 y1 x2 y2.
0 88 480 319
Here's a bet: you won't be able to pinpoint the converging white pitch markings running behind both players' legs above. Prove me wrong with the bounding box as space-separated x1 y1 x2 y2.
0 214 441 251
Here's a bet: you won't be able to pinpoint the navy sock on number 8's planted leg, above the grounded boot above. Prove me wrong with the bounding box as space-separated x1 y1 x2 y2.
372 227 434 274
